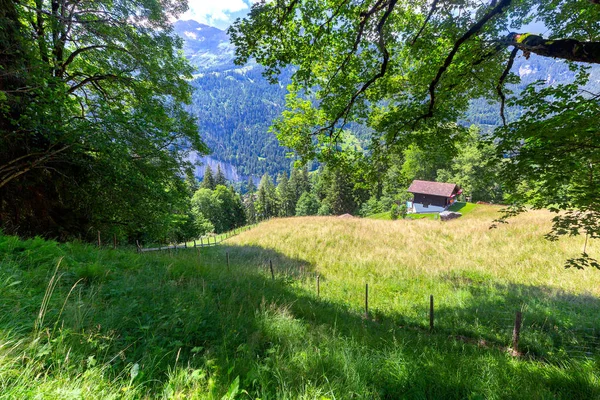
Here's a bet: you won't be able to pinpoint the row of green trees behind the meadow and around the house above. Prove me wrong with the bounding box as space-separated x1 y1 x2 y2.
164 125 496 242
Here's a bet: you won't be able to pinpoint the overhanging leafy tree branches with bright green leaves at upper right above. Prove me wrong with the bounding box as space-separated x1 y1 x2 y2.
230 0 600 268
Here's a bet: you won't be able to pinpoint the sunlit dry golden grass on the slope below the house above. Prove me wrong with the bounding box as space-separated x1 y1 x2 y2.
231 206 600 297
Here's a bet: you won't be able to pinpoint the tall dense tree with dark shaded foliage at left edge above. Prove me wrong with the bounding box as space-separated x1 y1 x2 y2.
0 0 206 237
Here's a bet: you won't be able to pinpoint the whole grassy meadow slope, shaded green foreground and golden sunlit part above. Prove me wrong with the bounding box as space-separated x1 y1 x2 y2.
0 206 600 399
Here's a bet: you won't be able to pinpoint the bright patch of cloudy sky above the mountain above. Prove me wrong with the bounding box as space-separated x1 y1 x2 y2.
180 0 258 29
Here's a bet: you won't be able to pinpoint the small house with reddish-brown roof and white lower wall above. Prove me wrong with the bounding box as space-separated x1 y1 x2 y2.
406 180 462 214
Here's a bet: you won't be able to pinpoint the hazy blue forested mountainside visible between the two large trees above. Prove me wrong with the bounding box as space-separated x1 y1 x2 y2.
175 21 291 181
